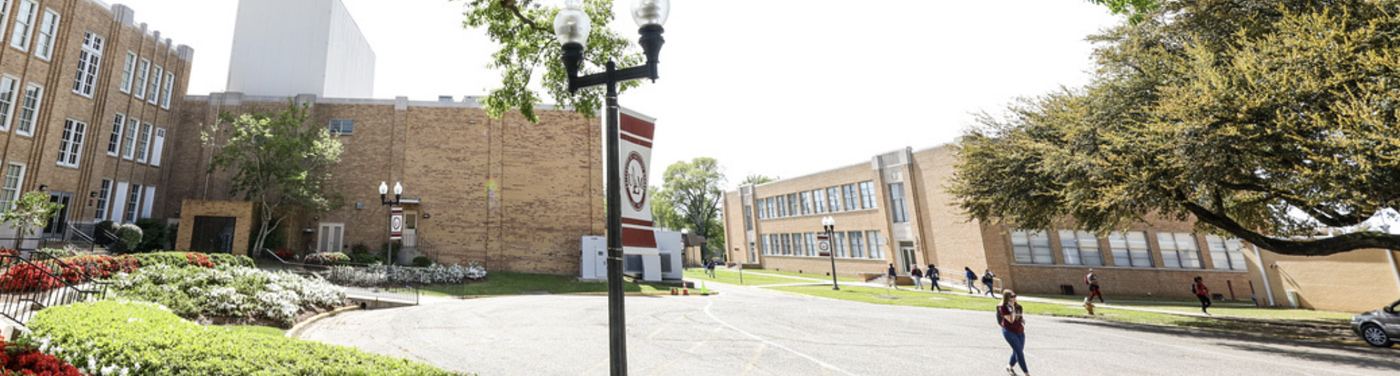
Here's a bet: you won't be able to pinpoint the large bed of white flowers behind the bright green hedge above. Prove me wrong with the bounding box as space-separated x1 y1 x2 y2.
112 264 346 326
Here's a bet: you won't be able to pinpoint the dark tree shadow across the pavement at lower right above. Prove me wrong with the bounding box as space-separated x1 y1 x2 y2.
1065 315 1400 372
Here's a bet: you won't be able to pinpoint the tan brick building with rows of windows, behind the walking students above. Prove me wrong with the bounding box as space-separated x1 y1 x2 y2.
722 145 1263 299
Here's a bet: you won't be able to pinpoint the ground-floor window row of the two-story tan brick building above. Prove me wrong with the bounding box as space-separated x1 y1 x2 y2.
757 231 885 260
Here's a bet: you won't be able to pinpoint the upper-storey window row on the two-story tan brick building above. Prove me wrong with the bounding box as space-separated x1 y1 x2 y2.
743 182 875 220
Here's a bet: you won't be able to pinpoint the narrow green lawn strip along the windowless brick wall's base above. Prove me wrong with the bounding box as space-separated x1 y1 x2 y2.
419 271 671 296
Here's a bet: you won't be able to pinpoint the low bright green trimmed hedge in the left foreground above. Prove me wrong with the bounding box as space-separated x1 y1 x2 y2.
29 301 455 376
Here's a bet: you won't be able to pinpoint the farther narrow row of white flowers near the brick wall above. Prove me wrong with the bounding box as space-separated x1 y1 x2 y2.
326 261 486 287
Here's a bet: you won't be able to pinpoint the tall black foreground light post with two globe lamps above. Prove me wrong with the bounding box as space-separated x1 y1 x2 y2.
554 0 671 376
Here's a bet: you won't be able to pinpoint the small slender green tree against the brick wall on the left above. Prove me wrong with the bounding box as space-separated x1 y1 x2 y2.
200 102 343 255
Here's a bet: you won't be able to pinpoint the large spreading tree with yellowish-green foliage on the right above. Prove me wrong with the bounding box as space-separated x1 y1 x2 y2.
949 0 1400 256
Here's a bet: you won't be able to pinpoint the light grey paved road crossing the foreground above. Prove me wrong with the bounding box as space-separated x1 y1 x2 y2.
301 279 1400 376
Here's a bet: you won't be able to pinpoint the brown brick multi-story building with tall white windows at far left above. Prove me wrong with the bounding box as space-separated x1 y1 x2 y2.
0 0 197 238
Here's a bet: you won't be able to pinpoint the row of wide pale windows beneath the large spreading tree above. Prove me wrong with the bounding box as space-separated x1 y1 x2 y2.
1011 229 1246 270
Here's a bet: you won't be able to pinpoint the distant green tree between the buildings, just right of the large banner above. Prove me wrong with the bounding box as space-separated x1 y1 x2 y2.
652 157 724 254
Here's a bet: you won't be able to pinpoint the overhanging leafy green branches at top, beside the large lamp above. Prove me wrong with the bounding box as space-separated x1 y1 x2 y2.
462 0 644 123
